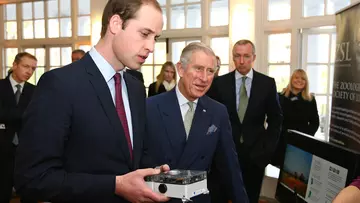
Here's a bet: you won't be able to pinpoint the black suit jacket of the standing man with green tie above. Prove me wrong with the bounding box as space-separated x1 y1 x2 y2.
207 70 282 168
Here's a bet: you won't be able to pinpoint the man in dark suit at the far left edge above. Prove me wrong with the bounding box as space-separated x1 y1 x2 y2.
0 52 37 203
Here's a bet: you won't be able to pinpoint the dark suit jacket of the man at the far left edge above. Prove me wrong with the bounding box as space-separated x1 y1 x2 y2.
0 76 35 202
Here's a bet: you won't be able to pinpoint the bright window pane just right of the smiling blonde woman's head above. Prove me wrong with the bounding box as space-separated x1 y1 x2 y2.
306 65 328 94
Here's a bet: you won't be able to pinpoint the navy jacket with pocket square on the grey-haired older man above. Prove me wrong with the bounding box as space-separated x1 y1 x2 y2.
143 88 248 203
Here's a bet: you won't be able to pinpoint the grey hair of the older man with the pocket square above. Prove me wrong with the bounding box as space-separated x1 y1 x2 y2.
180 42 217 69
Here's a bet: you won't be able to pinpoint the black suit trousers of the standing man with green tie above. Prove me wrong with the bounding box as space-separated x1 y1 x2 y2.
239 157 265 203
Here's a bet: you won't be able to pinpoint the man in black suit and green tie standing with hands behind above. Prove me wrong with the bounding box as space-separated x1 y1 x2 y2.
208 40 282 203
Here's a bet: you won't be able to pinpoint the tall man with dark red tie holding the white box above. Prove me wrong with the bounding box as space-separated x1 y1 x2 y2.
15 0 168 203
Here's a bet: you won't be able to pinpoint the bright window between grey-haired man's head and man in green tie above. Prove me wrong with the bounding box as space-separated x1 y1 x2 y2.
211 37 229 76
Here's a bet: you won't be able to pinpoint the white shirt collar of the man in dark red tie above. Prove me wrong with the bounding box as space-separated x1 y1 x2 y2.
89 47 125 82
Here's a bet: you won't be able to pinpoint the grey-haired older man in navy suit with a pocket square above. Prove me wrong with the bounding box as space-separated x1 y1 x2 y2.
143 42 248 203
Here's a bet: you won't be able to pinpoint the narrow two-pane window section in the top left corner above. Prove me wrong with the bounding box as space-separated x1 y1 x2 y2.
4 4 17 40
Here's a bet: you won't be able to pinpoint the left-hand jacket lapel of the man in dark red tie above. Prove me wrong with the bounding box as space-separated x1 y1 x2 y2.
83 54 132 168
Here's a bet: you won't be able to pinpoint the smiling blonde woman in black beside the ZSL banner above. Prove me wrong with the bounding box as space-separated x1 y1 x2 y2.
272 69 319 166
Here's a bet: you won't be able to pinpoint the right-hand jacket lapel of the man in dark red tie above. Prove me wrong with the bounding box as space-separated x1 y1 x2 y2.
124 72 144 169
